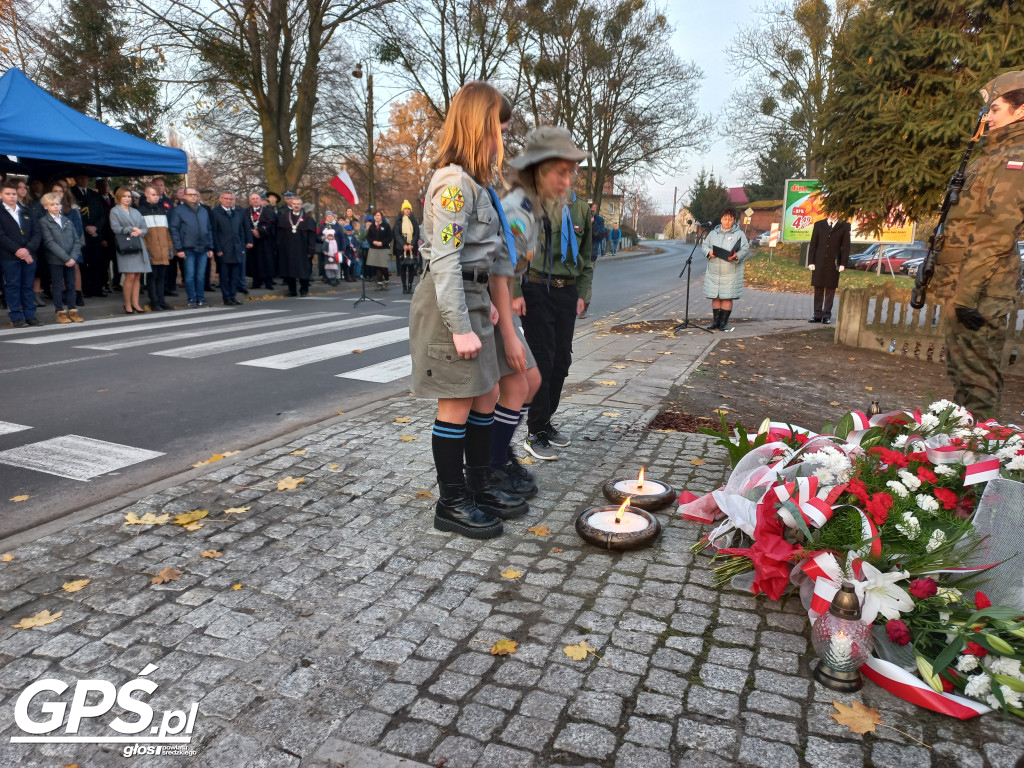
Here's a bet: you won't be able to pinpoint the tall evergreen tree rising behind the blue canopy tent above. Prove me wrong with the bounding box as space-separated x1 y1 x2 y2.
42 0 162 133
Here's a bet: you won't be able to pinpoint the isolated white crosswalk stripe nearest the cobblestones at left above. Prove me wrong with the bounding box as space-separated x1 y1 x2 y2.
0 434 164 481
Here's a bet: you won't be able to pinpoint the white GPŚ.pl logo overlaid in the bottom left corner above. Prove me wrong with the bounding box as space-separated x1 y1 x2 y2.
10 664 199 757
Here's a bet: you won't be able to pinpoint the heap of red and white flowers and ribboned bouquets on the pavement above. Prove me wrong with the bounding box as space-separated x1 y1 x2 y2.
680 400 1024 718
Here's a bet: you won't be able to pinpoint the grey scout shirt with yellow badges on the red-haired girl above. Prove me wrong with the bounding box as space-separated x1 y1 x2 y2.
420 165 505 335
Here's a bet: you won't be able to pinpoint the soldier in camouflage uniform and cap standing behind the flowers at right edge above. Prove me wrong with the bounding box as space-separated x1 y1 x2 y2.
933 72 1024 417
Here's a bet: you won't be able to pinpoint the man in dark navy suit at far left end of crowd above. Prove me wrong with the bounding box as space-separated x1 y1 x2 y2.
0 181 43 328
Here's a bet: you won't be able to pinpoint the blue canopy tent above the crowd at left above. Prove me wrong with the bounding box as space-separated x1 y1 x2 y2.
0 68 188 178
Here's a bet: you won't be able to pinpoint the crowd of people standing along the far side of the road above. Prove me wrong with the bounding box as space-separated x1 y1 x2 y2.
0 175 423 328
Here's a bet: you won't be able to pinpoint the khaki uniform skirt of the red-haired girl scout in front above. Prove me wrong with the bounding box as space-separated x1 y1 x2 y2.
409 272 501 400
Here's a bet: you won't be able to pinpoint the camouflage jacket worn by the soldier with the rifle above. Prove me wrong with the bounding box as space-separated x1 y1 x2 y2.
935 122 1024 307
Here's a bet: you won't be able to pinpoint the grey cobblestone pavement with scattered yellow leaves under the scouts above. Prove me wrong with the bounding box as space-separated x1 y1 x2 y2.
0 313 1024 768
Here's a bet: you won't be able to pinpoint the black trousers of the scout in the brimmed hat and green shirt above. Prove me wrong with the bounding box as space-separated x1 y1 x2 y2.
522 283 579 434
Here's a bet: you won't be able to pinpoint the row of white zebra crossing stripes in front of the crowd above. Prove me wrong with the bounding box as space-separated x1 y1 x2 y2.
0 305 412 385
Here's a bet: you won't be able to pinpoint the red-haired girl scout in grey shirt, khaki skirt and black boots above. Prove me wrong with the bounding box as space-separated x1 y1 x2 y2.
409 82 528 539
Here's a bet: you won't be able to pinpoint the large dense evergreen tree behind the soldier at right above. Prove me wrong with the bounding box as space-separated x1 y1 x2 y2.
821 0 1024 226
